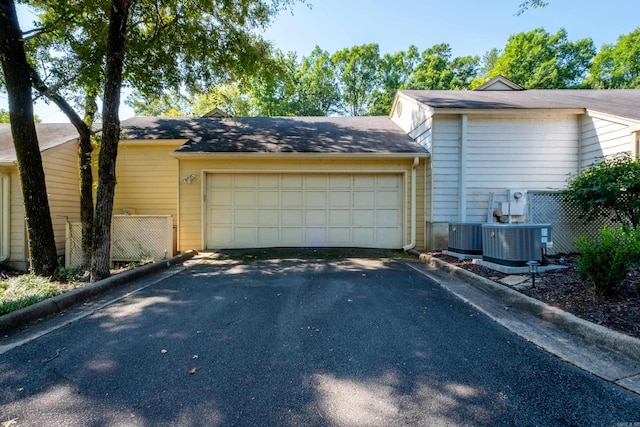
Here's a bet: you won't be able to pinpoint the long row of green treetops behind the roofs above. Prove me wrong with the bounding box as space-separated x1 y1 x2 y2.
129 24 640 116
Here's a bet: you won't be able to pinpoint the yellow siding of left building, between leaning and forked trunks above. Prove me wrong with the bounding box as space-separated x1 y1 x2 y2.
42 141 80 256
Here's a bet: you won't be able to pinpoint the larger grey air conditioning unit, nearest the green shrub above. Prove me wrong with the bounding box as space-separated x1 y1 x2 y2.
482 224 553 267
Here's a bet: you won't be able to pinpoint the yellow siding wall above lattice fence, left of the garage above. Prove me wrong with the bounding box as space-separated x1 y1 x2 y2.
113 143 179 225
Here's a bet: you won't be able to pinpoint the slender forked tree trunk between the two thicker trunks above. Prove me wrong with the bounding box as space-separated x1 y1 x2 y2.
30 67 98 270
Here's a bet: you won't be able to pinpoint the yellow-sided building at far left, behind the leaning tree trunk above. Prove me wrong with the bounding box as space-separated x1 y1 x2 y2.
0 123 80 270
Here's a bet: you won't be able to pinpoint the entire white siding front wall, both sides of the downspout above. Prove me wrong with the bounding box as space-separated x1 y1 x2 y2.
431 116 578 226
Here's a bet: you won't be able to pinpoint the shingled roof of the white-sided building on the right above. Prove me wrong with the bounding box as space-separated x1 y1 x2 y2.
400 89 640 120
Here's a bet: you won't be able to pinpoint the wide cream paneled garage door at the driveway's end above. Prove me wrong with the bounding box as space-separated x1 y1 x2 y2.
205 173 403 249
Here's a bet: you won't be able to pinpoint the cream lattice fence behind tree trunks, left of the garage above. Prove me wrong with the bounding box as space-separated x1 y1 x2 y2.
67 215 173 267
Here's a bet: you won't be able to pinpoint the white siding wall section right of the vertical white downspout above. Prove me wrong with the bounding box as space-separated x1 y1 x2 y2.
466 116 578 222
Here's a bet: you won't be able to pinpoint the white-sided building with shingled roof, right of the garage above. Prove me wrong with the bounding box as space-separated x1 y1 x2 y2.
391 77 640 249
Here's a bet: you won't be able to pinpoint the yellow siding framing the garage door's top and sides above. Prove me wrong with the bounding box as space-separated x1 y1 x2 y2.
178 156 424 251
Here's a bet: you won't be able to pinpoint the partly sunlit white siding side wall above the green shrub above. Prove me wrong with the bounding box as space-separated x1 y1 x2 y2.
580 115 632 169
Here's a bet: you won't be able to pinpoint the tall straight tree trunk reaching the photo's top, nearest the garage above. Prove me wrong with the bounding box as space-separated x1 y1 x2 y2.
91 0 130 281
